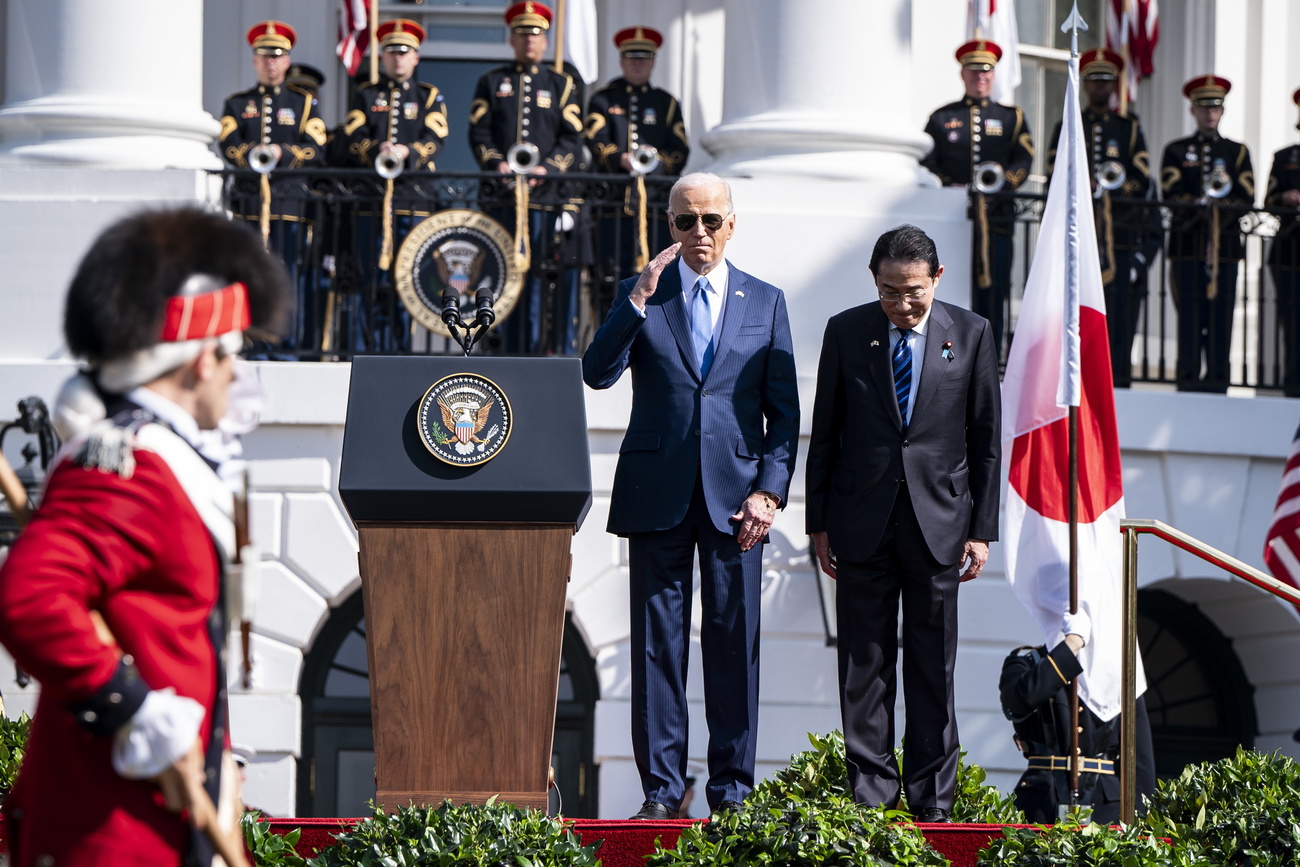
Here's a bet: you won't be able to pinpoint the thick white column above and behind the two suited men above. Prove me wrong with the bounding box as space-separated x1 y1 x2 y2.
702 0 936 187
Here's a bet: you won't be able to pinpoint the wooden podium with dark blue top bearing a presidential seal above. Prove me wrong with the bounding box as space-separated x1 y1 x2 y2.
338 356 592 810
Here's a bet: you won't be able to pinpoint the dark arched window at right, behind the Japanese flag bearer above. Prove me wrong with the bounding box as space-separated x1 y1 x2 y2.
1138 589 1257 777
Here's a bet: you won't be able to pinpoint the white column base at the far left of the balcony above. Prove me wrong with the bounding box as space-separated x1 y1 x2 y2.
0 0 221 169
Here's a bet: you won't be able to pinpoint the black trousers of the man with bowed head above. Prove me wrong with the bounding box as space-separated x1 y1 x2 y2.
836 485 959 812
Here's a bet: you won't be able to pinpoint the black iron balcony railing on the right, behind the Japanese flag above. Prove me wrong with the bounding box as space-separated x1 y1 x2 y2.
1004 194 1300 394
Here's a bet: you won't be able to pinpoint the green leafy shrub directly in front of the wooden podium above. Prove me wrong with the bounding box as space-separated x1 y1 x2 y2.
307 798 598 867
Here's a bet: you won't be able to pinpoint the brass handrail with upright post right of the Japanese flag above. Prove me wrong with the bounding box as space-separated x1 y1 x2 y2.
1119 519 1300 824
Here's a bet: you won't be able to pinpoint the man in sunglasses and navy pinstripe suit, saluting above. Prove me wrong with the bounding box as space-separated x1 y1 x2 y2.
582 174 800 819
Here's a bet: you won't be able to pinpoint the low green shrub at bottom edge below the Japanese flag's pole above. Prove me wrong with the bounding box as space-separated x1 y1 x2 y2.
976 823 1213 867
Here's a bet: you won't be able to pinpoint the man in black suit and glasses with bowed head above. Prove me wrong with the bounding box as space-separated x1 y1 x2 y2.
806 226 1001 822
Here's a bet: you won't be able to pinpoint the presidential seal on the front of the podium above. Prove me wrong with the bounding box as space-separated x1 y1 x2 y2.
416 373 514 467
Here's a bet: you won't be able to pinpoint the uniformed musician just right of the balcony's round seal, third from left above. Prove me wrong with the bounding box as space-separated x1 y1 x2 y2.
469 0 582 355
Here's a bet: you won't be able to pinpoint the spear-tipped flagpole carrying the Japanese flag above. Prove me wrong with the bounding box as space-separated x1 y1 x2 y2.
1061 1 1088 812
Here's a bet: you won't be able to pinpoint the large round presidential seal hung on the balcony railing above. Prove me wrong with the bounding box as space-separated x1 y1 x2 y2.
394 211 524 337
